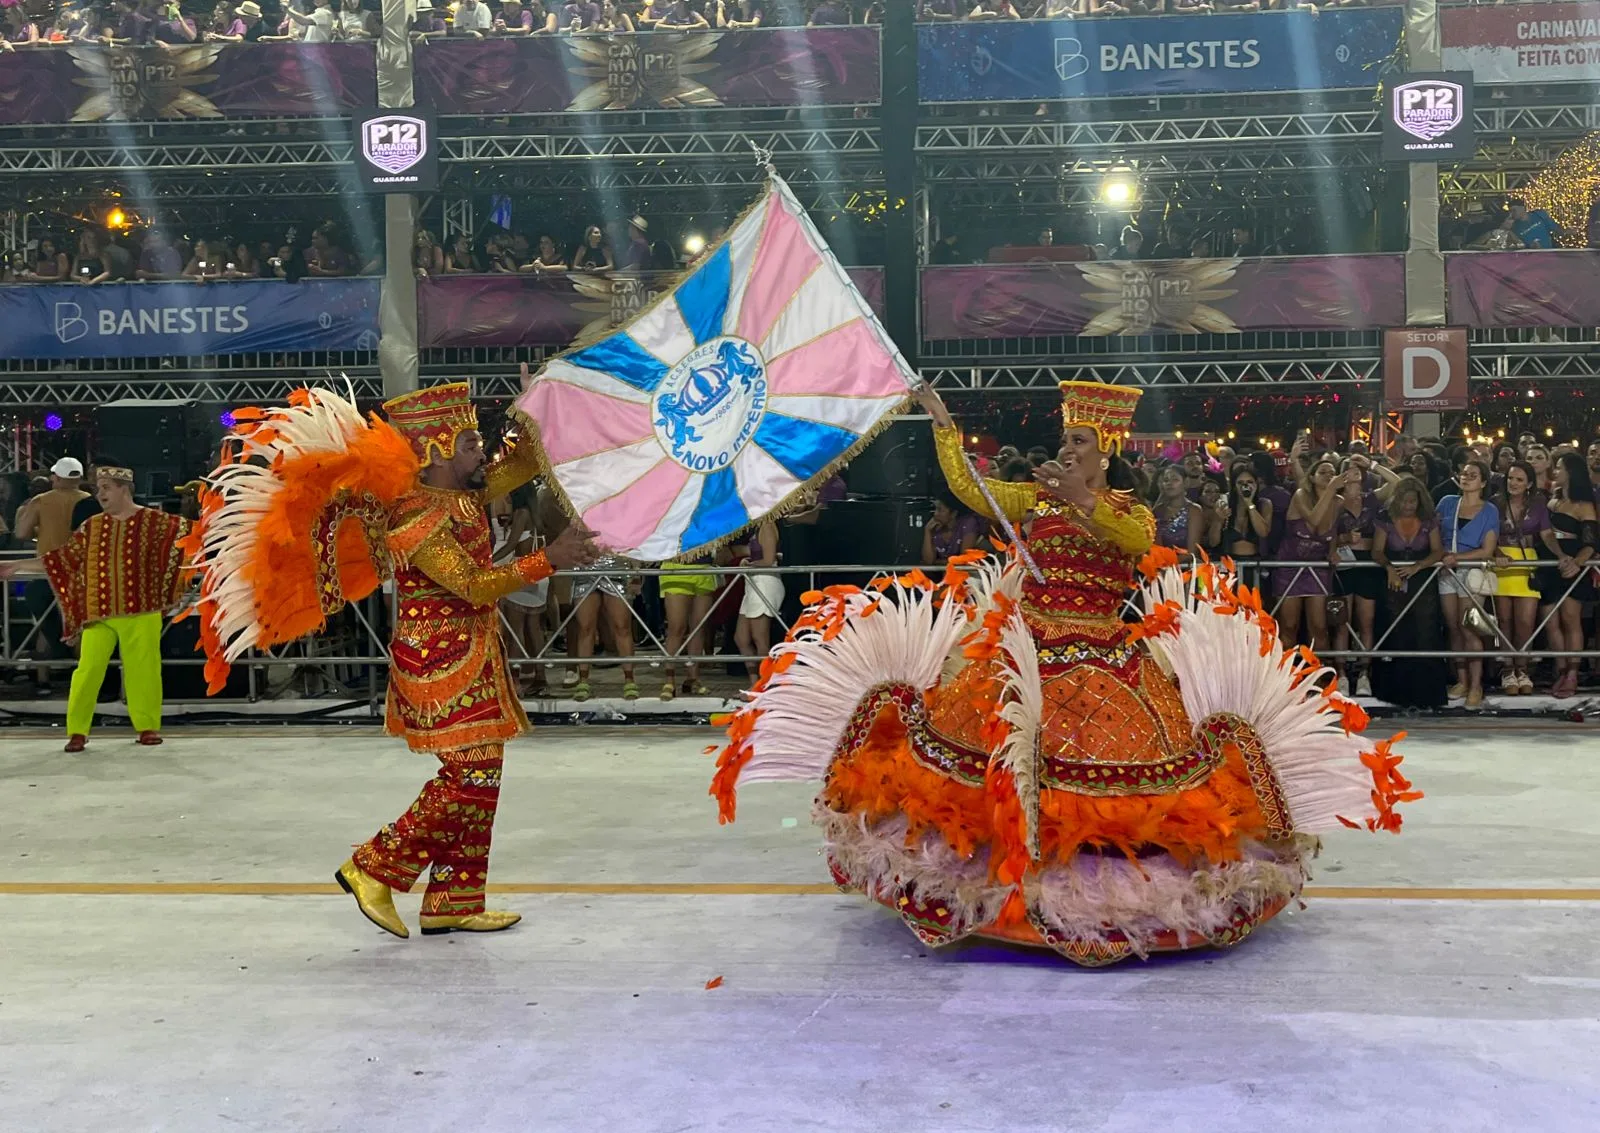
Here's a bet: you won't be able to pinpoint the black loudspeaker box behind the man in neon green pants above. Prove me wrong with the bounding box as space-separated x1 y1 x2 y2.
90 398 224 502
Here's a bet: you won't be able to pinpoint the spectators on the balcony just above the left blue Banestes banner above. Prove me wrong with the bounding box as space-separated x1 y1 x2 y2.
0 221 382 285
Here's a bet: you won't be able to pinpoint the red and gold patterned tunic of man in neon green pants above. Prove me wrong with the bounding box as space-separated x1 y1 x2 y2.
42 507 189 642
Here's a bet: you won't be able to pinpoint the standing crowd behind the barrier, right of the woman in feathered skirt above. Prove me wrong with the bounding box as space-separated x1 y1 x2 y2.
923 430 1600 709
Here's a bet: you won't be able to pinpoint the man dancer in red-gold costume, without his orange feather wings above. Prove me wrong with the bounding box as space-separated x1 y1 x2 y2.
336 382 595 936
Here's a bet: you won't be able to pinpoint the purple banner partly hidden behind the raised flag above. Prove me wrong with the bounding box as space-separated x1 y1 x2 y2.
416 267 883 349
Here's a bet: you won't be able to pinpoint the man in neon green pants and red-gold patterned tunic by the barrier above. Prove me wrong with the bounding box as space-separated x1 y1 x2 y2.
0 461 187 752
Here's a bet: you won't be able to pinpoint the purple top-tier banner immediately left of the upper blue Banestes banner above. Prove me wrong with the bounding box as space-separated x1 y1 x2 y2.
416 27 880 114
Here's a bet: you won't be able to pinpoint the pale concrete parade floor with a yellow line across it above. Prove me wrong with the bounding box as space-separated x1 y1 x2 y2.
0 725 1600 1133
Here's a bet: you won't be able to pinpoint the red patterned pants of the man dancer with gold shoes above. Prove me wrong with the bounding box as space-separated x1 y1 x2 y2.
355 744 504 917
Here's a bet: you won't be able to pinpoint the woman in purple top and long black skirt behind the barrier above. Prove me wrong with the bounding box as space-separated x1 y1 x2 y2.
1373 477 1450 707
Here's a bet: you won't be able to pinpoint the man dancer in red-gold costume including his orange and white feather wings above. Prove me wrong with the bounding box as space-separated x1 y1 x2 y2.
181 366 598 936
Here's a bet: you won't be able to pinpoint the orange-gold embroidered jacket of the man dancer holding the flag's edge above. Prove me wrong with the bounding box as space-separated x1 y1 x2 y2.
387 440 552 752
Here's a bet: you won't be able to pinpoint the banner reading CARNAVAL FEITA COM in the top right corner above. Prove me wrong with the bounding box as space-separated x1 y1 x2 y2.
1438 3 1600 83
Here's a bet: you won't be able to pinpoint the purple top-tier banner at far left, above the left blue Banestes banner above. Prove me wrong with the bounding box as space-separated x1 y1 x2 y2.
0 43 378 125
